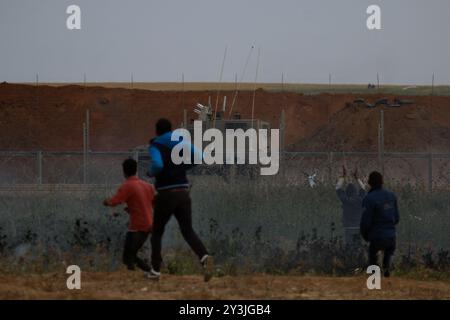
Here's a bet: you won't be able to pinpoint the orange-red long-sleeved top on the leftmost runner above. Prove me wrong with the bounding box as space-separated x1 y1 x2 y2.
108 176 156 232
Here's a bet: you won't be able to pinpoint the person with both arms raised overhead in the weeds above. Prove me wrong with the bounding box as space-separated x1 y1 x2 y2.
336 167 366 246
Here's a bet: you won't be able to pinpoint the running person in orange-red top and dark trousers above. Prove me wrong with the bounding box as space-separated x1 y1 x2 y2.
103 159 156 272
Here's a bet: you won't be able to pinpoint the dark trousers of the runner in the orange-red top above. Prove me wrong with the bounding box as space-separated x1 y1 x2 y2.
123 231 151 272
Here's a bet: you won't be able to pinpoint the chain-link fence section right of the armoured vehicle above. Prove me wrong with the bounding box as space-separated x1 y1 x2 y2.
281 152 450 190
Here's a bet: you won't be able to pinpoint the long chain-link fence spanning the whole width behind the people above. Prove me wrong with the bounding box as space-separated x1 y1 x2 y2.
0 151 450 190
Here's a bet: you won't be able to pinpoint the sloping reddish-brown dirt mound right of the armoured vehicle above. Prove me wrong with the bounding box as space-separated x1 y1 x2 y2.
291 98 450 153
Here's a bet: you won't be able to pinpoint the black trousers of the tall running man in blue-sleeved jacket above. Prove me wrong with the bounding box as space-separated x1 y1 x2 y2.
151 190 208 272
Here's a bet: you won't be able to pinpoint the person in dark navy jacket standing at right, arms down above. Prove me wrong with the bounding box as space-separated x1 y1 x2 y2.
360 171 400 277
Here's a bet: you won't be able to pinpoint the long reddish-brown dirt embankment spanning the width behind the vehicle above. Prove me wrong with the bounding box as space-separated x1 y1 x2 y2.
0 84 450 151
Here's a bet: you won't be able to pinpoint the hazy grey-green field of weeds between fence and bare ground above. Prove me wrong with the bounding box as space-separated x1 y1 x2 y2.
0 176 450 275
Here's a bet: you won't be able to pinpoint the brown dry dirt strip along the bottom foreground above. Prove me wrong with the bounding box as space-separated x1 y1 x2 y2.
0 272 450 299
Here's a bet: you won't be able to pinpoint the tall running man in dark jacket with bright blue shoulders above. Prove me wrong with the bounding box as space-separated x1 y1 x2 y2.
148 119 213 281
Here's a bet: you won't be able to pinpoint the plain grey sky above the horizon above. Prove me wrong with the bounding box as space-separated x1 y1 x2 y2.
0 0 450 84
